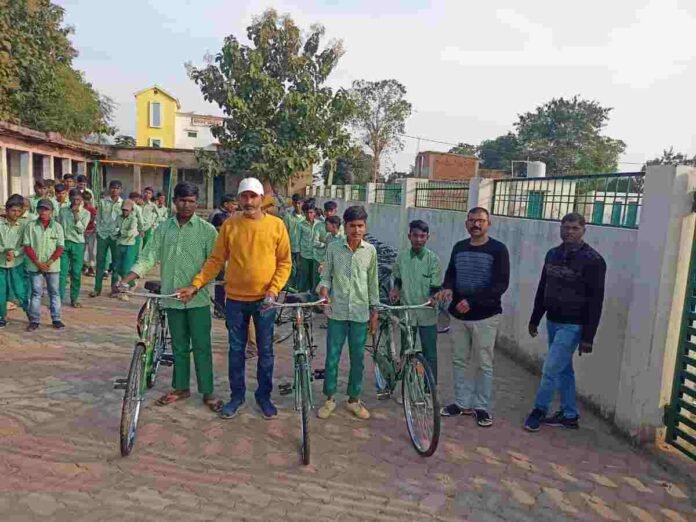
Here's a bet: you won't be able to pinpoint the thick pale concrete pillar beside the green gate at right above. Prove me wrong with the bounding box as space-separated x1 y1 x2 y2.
607 166 696 443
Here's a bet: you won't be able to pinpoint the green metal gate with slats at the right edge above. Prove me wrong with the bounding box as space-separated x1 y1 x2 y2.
665 230 696 460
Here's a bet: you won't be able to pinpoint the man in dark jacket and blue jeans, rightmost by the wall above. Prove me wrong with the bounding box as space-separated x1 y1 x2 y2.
524 213 607 431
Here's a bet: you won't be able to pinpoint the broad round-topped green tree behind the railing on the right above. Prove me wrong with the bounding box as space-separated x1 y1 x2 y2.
515 96 626 176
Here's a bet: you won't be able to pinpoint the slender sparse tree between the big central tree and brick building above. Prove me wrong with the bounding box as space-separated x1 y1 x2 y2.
352 80 411 183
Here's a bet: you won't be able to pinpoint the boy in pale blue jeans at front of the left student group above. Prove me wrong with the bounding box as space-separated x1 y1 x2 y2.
23 199 65 332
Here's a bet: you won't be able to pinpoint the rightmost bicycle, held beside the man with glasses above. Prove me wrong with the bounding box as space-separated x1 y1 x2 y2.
369 302 440 457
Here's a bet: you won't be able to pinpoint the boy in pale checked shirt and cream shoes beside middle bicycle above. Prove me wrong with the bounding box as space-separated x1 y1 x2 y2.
317 206 379 419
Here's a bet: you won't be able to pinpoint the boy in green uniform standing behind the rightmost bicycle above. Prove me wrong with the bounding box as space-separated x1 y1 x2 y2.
389 219 442 382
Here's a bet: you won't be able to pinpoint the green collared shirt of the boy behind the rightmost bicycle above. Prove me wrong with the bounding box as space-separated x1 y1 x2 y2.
392 247 442 326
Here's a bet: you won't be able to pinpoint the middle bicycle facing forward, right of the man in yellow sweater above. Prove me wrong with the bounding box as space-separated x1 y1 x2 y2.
270 293 324 466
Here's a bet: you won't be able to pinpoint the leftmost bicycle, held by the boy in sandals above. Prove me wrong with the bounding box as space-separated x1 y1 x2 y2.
114 281 178 457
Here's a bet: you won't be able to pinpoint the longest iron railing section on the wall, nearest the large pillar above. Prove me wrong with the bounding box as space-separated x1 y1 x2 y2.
492 172 645 228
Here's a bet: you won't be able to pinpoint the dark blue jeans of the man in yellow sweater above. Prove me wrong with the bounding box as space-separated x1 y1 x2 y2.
225 299 275 401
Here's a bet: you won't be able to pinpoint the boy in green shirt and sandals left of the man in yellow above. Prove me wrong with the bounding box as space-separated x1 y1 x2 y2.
121 183 221 411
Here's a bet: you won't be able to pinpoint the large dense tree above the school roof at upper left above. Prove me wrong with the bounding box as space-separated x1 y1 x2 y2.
0 0 114 138
